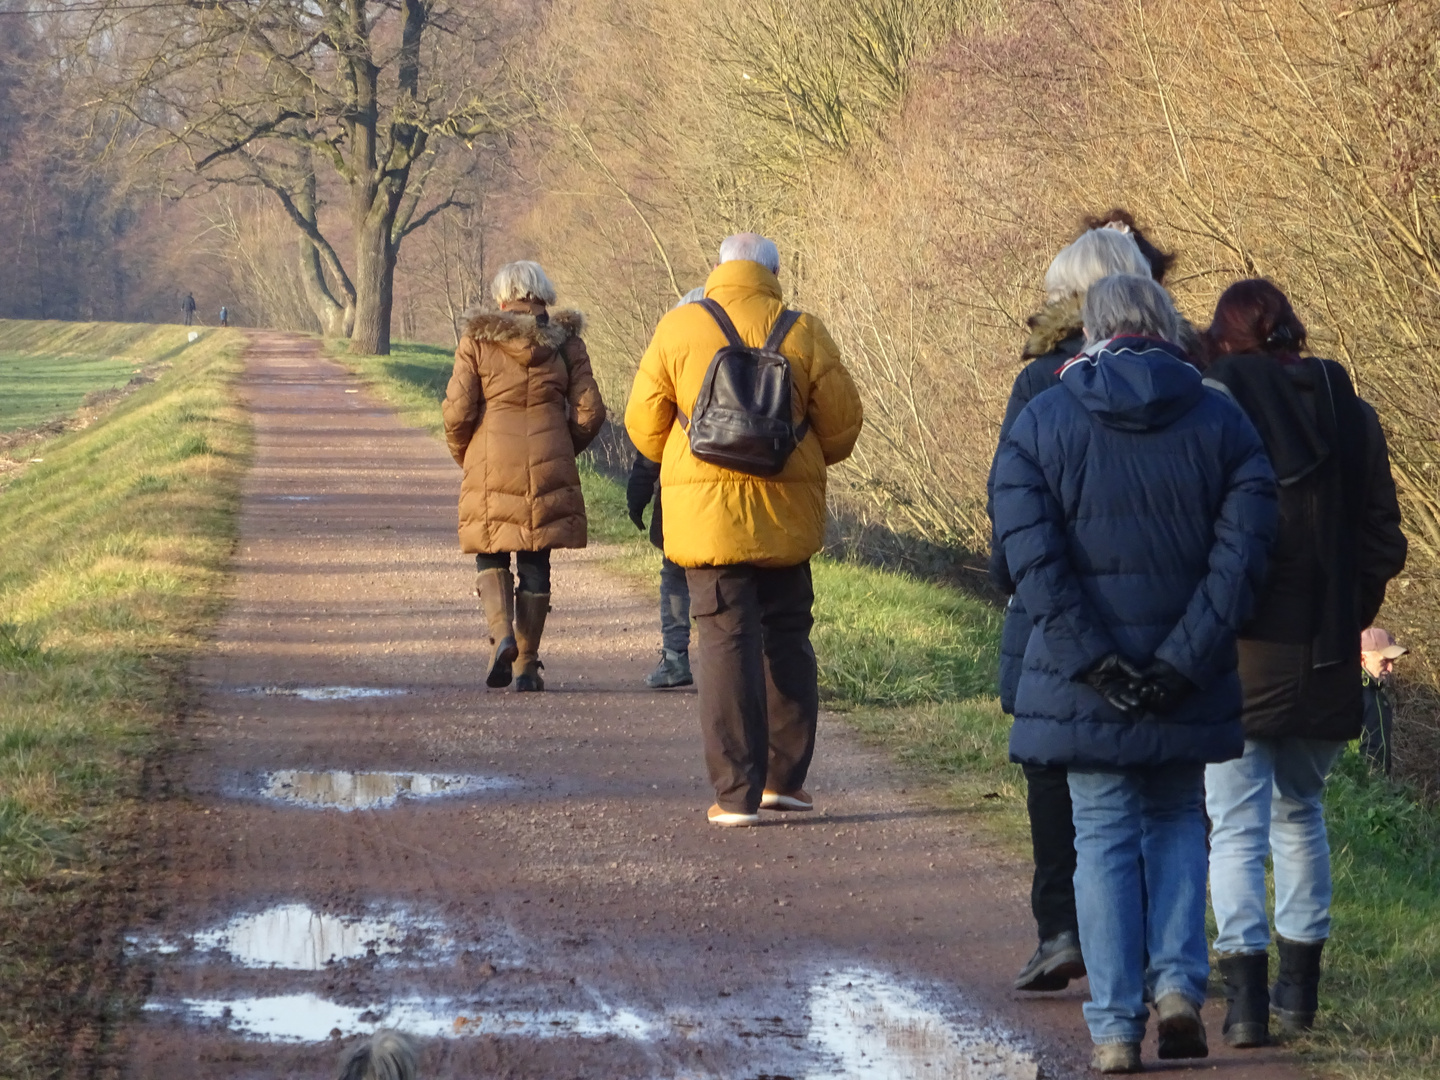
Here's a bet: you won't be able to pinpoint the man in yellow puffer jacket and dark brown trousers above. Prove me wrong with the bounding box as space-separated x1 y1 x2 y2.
625 233 861 825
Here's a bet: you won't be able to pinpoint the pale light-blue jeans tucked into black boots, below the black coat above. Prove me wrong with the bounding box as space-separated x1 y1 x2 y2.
1205 739 1345 953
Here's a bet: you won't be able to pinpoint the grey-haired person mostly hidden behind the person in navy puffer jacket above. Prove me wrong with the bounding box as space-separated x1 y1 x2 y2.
988 220 1152 991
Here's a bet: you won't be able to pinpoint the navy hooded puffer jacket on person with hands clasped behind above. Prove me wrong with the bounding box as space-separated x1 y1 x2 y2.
995 338 1273 766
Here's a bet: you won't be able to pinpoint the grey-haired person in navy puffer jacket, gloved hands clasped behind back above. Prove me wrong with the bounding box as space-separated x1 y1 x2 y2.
995 275 1276 1073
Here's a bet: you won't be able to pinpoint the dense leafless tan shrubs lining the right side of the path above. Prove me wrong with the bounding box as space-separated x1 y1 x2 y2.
523 0 1440 777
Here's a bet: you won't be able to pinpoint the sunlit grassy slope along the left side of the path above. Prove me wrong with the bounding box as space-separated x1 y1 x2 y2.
0 321 249 1077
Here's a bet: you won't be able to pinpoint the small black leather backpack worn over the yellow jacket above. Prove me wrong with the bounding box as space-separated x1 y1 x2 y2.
680 297 809 477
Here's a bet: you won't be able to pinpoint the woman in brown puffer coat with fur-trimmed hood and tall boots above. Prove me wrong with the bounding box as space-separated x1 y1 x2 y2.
444 262 605 690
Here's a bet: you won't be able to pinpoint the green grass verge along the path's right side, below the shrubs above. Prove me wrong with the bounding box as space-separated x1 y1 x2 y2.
347 338 1440 1080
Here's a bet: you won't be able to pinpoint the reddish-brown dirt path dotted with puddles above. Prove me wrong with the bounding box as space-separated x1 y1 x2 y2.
114 336 1295 1080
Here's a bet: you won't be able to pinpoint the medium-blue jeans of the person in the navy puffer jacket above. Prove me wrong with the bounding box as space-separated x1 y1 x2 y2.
1070 763 1210 1044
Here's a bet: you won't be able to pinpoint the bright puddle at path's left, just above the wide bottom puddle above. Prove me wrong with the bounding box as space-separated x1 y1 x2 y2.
131 904 451 971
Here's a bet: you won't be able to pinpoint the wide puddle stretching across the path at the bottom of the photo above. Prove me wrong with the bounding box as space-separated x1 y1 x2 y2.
145 969 1038 1080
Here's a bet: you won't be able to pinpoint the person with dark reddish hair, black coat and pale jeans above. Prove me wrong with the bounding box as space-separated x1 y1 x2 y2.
1205 279 1405 1047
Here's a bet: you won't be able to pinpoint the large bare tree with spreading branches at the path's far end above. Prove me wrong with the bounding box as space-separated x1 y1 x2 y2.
68 0 512 354
